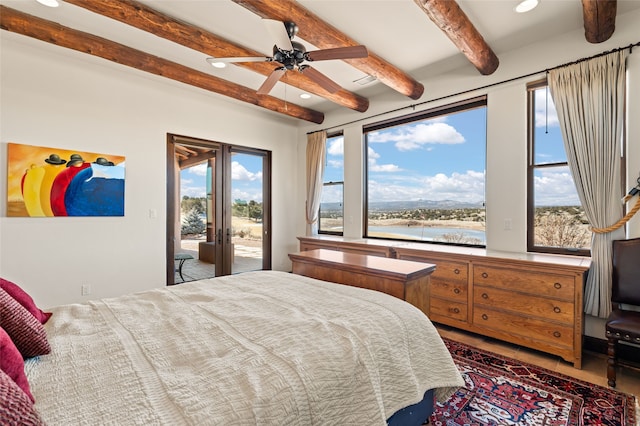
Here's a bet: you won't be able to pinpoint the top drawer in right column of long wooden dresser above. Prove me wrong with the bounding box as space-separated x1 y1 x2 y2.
473 265 575 301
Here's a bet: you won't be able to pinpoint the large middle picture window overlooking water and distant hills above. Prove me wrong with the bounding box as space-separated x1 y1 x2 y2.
364 97 487 246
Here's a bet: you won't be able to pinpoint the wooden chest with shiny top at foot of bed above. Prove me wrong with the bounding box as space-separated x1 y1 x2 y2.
289 249 435 314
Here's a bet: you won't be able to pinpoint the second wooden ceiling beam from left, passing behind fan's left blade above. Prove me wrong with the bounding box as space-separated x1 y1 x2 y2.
65 0 369 112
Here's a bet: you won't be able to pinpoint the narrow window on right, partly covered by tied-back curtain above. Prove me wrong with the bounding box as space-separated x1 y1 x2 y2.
527 81 591 255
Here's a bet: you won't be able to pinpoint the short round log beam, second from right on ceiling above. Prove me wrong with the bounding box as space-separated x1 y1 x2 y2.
414 0 500 75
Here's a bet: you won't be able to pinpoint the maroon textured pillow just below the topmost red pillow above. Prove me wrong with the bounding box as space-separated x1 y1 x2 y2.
0 288 51 358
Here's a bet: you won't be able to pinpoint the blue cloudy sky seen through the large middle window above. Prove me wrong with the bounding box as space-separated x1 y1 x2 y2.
368 108 486 205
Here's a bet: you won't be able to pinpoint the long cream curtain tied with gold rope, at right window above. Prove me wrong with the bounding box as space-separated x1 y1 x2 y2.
549 49 628 318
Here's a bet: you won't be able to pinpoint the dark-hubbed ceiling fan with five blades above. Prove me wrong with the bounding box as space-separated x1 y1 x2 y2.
207 19 369 95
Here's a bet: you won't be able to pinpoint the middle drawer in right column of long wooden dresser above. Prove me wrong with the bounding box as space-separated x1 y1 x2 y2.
473 286 575 327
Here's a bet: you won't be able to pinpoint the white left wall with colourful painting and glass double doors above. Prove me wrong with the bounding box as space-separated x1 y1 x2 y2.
0 31 297 307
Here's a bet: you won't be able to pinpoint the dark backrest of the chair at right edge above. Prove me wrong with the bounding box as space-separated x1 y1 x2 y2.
611 238 640 306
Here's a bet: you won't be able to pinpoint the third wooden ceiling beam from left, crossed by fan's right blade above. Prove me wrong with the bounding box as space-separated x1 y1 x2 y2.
233 0 424 99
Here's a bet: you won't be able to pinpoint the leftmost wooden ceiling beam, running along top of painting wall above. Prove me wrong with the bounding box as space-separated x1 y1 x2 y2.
0 5 324 124
